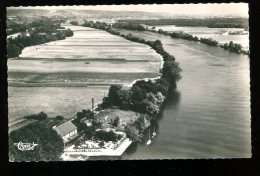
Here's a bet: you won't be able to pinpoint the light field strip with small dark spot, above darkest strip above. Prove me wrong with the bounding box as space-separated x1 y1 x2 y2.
8 59 159 73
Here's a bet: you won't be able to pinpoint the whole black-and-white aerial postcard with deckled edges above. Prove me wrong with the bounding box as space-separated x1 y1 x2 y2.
6 3 252 162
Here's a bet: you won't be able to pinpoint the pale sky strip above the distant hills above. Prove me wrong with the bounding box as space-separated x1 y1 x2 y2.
7 3 248 17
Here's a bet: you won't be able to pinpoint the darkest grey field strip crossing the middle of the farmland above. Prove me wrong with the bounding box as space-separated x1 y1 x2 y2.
8 72 159 87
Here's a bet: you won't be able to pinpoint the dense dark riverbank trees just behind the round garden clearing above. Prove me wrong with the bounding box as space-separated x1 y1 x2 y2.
100 78 167 117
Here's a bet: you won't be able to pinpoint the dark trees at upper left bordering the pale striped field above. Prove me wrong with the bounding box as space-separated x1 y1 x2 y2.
7 20 73 58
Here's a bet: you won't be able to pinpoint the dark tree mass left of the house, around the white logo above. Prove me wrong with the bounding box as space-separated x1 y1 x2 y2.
9 122 63 161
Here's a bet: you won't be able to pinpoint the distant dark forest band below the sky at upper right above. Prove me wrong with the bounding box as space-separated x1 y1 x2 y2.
118 18 248 30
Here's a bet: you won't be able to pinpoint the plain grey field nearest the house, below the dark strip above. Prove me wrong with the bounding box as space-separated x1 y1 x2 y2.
8 86 109 124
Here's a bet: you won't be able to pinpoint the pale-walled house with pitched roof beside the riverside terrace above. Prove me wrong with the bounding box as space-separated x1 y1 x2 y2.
53 121 78 143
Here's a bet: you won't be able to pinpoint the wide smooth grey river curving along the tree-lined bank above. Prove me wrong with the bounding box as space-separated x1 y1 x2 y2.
119 31 251 159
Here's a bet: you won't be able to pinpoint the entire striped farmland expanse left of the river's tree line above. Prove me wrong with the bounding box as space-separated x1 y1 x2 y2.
8 25 161 125
